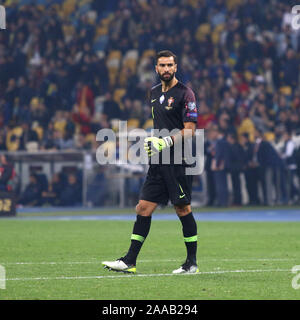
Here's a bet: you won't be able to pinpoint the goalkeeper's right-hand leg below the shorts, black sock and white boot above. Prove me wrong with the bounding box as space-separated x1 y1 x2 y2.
173 205 199 273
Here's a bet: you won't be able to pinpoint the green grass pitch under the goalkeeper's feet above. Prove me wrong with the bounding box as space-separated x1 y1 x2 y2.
0 220 300 300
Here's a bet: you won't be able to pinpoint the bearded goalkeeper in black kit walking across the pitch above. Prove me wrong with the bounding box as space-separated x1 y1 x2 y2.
102 50 199 273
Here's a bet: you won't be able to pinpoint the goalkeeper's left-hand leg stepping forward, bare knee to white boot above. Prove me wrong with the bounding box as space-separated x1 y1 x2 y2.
102 200 157 273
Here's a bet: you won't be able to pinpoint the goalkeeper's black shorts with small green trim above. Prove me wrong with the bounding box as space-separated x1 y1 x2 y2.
140 164 193 205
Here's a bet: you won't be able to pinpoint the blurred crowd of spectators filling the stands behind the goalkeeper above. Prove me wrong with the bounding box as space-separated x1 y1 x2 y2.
0 0 300 206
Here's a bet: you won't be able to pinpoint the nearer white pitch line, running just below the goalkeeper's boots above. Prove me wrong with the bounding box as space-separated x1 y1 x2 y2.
6 269 291 281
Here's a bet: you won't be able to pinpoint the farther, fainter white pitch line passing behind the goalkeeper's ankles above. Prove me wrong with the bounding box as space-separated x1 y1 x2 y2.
0 257 300 265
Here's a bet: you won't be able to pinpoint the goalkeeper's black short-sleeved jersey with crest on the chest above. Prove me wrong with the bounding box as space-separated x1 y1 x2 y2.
150 81 198 163
